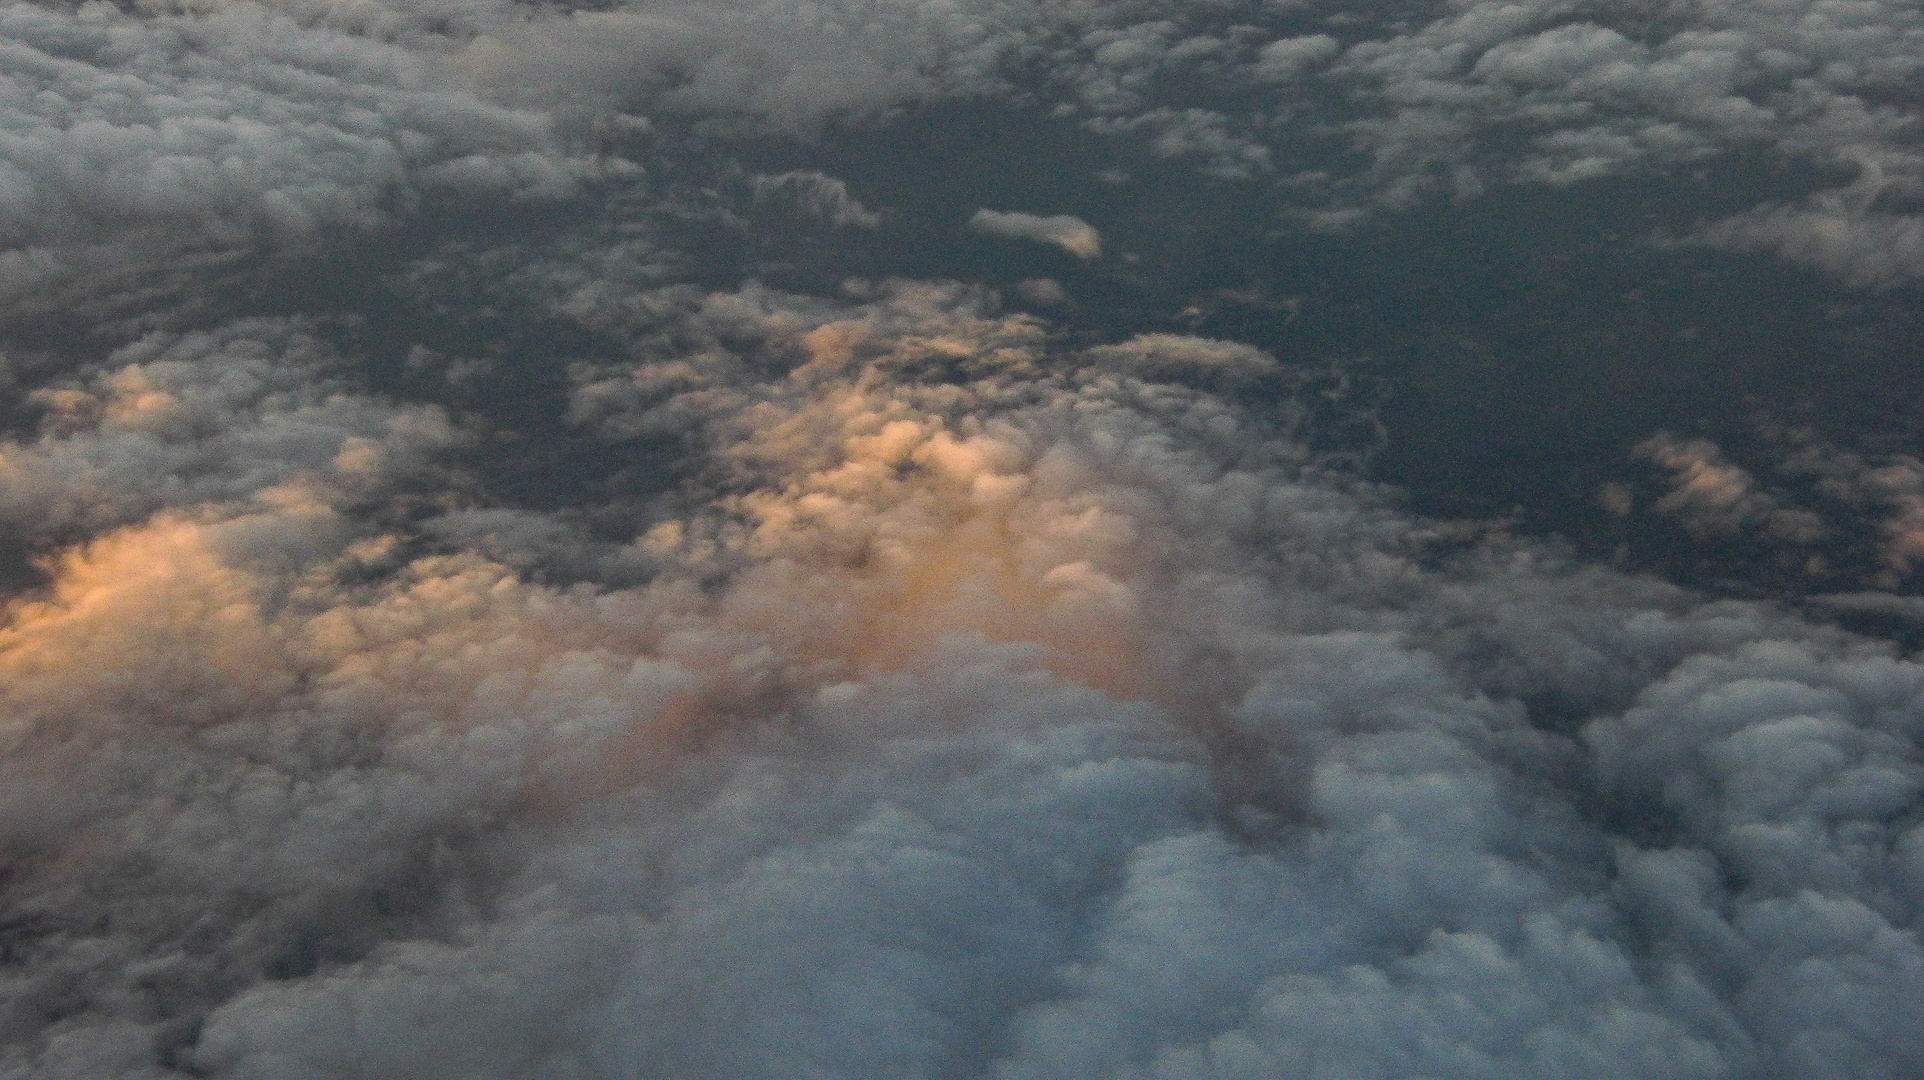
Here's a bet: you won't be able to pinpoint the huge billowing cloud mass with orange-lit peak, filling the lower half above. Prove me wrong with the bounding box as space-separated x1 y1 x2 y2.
0 283 1924 1078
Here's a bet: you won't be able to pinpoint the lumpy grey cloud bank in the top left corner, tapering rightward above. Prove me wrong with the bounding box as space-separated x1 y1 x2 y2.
0 4 621 300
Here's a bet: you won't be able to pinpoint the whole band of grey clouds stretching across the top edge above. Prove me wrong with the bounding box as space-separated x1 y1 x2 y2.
0 0 1924 285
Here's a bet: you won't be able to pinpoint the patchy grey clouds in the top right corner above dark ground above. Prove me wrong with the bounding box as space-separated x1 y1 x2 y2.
1262 2 1924 261
